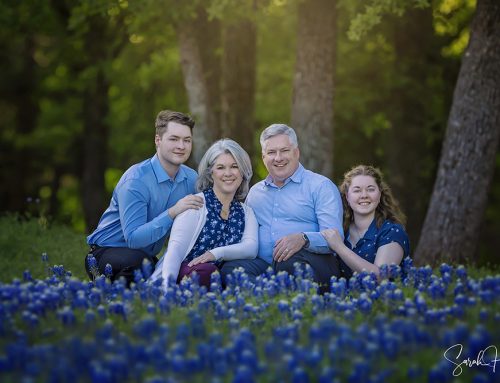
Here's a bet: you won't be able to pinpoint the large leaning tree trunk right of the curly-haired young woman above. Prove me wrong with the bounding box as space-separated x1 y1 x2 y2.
415 0 500 265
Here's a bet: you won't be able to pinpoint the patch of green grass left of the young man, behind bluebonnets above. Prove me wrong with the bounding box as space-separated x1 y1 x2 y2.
0 214 88 282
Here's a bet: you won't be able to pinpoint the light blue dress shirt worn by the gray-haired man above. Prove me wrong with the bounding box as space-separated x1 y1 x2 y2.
246 164 344 264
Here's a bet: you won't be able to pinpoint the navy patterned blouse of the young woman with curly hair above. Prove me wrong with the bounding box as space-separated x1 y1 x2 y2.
340 220 410 279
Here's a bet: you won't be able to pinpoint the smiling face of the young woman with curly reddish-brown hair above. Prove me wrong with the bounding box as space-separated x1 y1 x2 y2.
346 175 381 215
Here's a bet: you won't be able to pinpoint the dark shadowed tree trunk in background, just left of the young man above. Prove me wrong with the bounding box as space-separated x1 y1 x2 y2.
82 16 109 230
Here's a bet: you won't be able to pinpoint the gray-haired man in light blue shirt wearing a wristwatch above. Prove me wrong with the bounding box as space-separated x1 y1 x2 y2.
221 124 343 288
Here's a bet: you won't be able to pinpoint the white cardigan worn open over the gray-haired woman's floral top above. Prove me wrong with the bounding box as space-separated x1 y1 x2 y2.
150 193 259 288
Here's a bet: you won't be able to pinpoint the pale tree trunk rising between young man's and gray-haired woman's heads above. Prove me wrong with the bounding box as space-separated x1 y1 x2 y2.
177 10 220 165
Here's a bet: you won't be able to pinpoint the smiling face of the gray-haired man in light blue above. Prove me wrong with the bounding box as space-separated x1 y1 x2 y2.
262 134 300 186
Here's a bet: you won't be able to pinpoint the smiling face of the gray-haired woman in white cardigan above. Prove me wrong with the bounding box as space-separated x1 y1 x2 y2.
212 153 243 199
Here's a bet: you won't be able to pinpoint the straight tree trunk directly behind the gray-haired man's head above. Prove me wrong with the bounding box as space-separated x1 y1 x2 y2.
292 0 336 177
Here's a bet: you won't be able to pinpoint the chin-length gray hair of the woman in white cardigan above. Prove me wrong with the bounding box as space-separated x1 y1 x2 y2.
196 138 253 201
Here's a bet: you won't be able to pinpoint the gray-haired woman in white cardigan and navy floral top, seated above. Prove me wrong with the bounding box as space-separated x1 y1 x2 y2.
151 139 258 288
